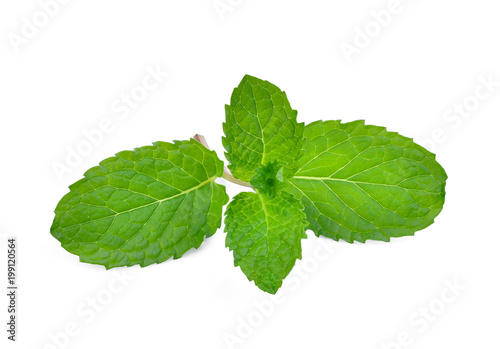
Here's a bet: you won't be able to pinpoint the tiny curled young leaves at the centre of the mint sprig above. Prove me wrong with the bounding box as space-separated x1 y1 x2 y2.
250 161 286 197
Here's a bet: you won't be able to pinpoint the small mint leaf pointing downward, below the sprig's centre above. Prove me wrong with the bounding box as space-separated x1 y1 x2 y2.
224 192 307 294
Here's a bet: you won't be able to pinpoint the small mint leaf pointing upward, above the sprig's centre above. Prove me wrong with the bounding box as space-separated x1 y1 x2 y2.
222 75 304 182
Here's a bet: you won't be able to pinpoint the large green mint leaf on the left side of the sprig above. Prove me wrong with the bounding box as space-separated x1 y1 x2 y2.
51 140 228 268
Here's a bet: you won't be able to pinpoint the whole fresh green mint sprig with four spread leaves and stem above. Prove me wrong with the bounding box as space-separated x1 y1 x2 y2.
51 75 447 294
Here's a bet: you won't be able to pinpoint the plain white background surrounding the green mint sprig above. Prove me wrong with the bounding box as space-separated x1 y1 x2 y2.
0 0 500 349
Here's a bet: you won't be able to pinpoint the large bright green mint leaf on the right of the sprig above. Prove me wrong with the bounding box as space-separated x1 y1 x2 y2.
289 121 447 242
